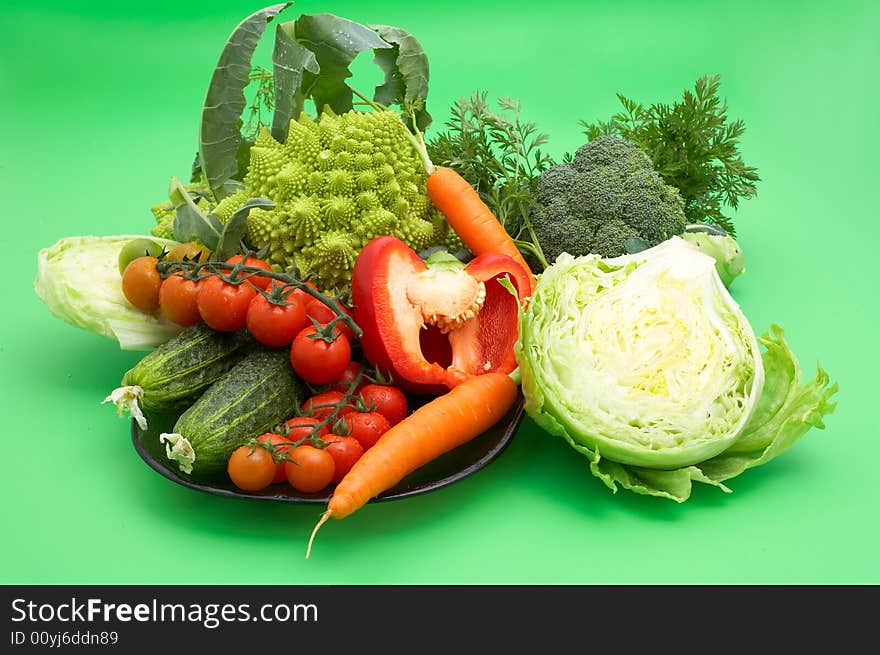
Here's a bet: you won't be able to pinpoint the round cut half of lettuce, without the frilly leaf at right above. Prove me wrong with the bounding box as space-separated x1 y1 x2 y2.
520 237 764 469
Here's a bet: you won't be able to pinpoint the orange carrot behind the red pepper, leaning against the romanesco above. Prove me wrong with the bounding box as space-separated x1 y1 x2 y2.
428 166 536 295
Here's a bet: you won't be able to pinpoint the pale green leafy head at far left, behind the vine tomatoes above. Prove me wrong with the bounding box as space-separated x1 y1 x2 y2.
34 235 181 350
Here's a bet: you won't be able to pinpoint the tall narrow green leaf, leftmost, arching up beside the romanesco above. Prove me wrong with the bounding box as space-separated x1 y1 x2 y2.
199 2 293 197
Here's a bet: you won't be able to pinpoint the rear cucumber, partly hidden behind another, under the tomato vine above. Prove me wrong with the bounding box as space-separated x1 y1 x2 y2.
122 323 254 412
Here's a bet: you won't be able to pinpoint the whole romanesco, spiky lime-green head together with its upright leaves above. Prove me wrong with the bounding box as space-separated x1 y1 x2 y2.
153 5 454 291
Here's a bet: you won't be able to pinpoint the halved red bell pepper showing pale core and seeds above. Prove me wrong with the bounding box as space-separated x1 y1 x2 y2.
352 236 531 393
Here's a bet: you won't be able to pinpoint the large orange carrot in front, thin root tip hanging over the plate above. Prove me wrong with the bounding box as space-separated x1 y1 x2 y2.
306 373 519 557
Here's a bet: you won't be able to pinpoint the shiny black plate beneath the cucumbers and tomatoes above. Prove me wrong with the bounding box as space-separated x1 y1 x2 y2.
131 395 523 503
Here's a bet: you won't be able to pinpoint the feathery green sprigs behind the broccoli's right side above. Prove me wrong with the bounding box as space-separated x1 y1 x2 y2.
580 75 760 235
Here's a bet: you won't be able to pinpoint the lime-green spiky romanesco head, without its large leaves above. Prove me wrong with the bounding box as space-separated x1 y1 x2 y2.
156 110 462 291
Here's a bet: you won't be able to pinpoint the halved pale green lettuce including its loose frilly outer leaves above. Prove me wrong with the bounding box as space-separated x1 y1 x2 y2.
517 237 837 502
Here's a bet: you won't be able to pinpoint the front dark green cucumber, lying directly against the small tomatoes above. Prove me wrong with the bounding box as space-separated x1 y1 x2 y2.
159 347 306 480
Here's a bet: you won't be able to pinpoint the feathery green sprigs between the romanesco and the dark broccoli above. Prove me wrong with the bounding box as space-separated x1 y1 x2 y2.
426 92 555 260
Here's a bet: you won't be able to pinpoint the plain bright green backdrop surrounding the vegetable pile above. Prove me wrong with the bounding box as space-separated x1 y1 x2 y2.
0 0 880 584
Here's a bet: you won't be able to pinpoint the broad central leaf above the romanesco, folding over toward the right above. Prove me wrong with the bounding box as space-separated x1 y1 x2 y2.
293 14 392 114
